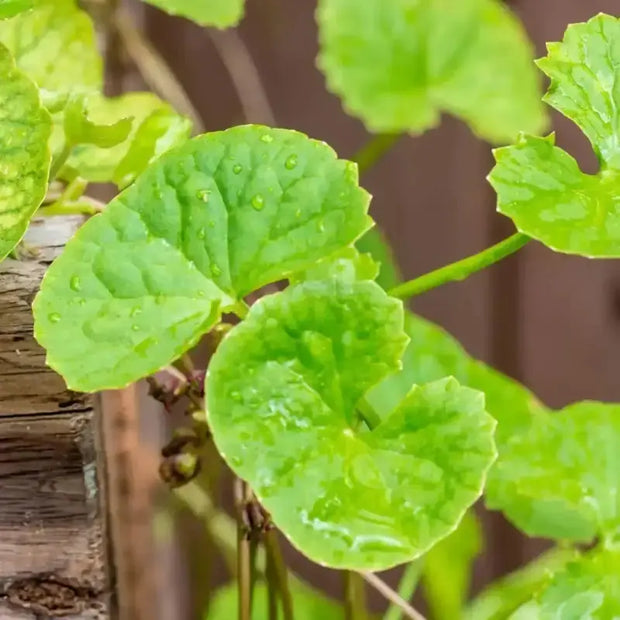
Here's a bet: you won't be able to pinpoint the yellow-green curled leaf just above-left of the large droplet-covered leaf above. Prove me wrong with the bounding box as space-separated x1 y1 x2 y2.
65 93 191 187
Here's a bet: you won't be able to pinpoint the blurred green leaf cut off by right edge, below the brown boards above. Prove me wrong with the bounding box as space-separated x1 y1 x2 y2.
486 402 620 541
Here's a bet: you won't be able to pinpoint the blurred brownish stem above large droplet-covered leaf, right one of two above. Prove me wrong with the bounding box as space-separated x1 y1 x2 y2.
209 29 276 126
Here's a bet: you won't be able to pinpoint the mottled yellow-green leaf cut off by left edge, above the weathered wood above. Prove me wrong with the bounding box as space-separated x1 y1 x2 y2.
0 45 52 260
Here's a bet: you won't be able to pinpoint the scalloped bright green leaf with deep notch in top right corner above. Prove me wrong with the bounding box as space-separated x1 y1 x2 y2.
489 15 620 258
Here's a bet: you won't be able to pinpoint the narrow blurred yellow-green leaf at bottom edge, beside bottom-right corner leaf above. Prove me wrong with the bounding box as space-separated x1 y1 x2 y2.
464 547 578 620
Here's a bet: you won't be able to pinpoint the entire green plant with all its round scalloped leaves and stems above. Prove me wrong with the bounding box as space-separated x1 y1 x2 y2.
0 0 620 620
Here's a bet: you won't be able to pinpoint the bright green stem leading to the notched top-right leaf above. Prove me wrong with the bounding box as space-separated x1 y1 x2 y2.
389 233 530 299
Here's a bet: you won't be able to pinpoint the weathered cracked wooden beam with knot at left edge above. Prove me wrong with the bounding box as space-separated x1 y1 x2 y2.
0 218 111 620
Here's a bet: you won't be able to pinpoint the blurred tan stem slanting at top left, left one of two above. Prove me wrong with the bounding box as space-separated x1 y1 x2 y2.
114 9 204 133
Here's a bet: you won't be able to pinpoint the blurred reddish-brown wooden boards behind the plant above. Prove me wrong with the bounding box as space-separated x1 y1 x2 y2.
117 0 620 620
